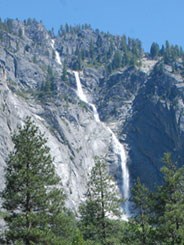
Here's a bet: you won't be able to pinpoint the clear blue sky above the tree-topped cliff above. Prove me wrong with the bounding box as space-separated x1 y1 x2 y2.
0 0 184 51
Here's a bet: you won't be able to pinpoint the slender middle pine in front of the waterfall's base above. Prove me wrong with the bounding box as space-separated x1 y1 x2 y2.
80 158 122 244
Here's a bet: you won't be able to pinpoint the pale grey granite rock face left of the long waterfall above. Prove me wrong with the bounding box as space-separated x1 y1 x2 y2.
0 21 111 210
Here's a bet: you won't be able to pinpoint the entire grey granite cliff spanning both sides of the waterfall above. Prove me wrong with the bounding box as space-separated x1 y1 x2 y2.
0 20 184 209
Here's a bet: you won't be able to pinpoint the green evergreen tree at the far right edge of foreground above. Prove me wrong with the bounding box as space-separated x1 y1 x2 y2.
155 153 184 244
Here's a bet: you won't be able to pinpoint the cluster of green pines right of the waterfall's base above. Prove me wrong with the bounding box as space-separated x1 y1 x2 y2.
129 153 184 245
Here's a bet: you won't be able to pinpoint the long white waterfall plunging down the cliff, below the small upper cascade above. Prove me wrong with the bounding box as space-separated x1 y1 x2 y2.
74 71 130 220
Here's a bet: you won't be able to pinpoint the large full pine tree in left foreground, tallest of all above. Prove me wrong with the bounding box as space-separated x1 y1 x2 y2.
2 117 70 245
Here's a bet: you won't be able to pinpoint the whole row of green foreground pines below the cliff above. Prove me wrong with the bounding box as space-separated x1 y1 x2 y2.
0 117 184 245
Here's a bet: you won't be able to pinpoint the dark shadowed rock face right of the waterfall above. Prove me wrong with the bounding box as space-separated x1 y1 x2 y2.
125 64 184 188
